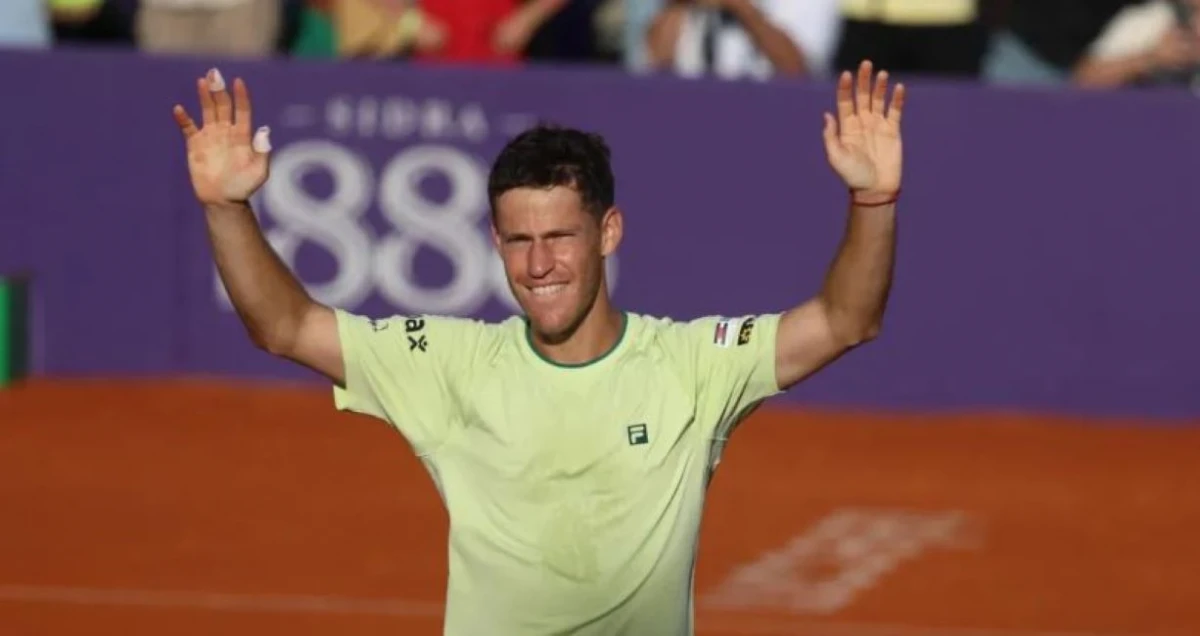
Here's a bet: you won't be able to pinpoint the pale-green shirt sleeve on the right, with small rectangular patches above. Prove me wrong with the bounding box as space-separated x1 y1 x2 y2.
684 313 780 438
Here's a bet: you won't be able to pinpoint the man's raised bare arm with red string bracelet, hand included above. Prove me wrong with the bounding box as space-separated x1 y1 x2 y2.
775 62 905 389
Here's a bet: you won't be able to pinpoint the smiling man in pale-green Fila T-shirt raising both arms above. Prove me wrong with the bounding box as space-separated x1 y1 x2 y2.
174 57 905 636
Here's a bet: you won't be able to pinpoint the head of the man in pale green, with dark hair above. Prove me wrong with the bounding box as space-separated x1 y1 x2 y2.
487 126 622 341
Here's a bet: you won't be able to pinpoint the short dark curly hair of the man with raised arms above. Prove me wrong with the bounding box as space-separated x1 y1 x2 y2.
487 124 617 220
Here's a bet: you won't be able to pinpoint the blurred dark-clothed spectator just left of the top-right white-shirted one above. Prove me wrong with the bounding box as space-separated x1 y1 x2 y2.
983 0 1146 85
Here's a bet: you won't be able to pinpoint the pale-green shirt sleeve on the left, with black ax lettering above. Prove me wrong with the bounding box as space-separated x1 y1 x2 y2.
334 310 485 455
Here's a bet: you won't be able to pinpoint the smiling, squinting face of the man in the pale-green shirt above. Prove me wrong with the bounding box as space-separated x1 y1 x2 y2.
493 186 622 341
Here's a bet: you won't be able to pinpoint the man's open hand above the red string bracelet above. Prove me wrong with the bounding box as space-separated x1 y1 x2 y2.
824 61 905 197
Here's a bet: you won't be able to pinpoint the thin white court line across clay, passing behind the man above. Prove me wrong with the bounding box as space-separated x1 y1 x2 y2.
0 586 1152 636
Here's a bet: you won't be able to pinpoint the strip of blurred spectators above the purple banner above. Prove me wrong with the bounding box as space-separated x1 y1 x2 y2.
0 0 1200 88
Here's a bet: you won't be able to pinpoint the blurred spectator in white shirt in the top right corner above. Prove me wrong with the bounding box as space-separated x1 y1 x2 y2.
1074 0 1200 88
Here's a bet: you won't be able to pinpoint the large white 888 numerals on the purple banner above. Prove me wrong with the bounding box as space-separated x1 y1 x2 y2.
216 139 617 316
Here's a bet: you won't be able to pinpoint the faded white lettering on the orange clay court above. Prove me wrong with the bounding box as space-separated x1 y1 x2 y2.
704 509 966 614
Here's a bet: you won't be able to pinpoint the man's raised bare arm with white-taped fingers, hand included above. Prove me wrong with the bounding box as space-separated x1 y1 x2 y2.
174 70 346 385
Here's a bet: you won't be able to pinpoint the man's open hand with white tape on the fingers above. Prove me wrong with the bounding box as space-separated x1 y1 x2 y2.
174 68 271 208
